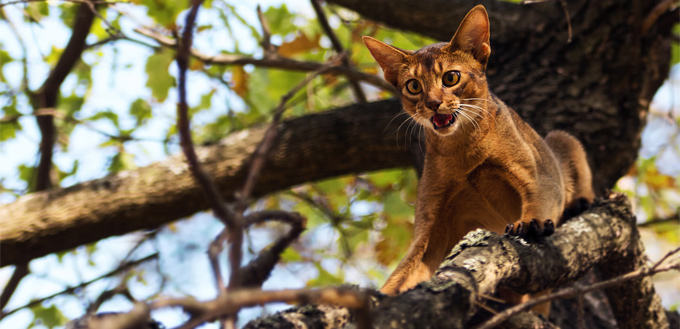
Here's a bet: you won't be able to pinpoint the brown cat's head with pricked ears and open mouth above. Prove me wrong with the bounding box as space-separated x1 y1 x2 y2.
364 5 491 136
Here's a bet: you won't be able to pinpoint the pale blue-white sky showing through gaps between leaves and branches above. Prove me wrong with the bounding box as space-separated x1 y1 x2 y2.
0 0 680 328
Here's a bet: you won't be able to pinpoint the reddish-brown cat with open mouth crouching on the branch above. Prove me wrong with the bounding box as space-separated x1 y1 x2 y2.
364 5 594 302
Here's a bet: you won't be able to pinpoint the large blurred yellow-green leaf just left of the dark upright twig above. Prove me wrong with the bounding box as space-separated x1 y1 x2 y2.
145 49 175 102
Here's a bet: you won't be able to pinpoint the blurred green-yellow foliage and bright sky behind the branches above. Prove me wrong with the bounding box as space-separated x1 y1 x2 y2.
0 0 680 328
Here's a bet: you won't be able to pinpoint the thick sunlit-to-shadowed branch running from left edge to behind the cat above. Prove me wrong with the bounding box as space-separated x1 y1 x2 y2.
0 101 411 266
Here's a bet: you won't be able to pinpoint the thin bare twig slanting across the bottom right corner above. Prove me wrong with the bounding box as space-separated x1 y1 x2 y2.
475 248 680 329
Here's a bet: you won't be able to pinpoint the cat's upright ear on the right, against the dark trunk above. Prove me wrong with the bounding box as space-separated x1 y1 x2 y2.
449 5 491 67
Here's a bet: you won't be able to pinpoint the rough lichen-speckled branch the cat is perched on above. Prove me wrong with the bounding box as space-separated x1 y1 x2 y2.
246 198 668 328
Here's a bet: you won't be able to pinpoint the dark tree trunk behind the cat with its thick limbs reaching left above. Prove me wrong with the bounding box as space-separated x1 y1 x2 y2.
0 0 677 266
